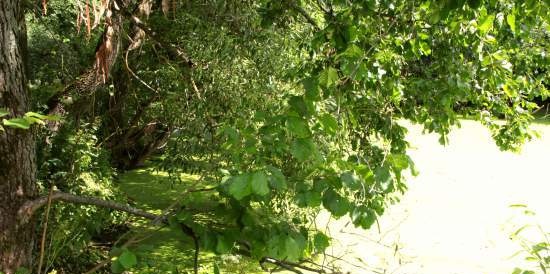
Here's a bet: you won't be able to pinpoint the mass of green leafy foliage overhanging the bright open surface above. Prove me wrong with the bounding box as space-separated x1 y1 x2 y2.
0 0 550 271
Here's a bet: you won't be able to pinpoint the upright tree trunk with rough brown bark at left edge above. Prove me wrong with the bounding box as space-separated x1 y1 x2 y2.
0 0 37 274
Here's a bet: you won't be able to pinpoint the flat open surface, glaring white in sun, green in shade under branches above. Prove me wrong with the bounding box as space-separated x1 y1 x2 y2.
121 120 550 274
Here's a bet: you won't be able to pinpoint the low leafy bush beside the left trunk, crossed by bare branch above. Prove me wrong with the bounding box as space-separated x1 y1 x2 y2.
39 121 127 273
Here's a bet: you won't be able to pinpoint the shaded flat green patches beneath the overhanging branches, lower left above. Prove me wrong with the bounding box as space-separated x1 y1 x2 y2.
119 169 263 274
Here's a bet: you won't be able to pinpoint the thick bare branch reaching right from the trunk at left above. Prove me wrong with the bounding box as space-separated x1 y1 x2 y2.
18 191 161 223
